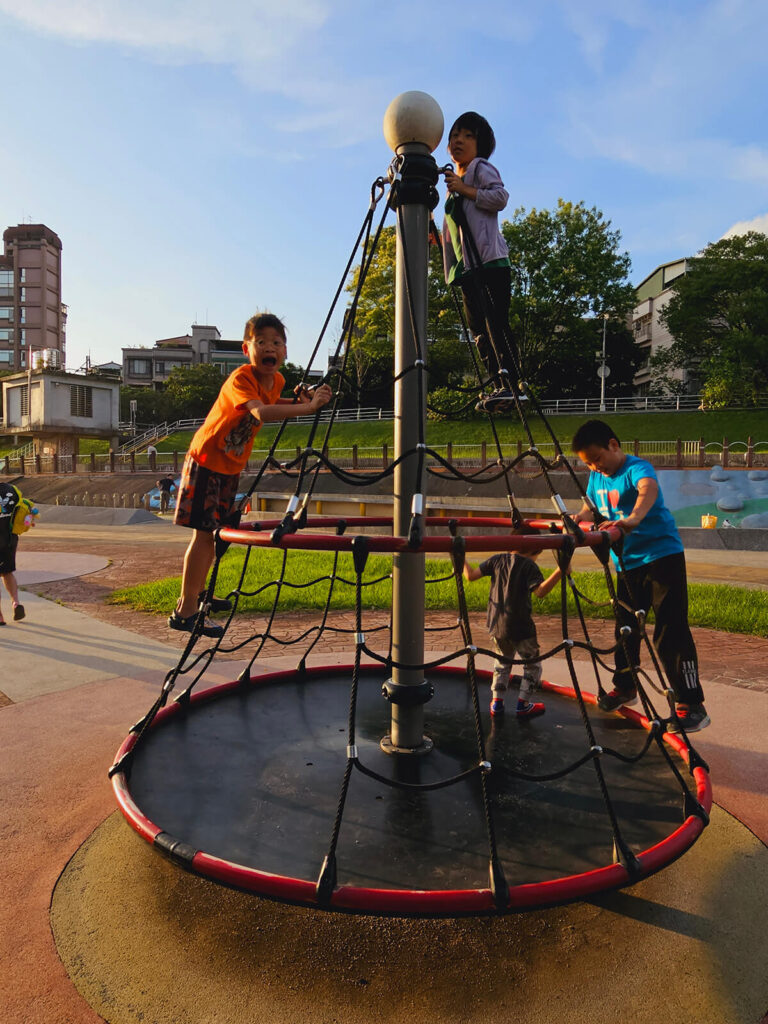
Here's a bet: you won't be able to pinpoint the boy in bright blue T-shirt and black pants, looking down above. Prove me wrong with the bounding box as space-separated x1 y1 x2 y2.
571 420 710 732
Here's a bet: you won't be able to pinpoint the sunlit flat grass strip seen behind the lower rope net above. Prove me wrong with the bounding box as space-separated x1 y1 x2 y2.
110 548 768 636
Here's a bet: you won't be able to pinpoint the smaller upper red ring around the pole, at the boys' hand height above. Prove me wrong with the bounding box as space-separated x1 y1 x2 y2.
219 516 622 554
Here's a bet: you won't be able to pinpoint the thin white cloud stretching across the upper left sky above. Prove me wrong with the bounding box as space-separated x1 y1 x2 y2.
0 0 391 146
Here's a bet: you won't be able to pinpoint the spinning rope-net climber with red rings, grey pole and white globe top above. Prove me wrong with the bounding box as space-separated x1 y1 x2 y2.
111 93 712 915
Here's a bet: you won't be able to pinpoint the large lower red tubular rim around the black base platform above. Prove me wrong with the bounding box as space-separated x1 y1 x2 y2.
112 665 712 916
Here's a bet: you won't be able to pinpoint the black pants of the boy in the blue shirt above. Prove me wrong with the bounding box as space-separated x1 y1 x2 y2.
613 551 703 705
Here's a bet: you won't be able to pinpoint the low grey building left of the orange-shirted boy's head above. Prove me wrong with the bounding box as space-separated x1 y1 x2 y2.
123 324 246 391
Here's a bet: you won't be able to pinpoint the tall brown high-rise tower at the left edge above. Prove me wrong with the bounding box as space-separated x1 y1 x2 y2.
0 224 67 371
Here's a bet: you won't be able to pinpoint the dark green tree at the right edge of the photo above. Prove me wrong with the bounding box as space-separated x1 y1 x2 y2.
651 231 768 408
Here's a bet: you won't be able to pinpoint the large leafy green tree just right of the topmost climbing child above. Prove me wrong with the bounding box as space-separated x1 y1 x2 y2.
502 200 635 397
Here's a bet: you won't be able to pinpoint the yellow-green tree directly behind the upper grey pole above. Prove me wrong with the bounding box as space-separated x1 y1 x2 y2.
347 227 471 404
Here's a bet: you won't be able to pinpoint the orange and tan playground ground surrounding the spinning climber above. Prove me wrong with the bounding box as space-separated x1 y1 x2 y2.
0 523 768 1024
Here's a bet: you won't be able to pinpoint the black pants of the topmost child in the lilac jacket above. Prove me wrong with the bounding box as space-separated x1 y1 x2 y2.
461 266 517 386
